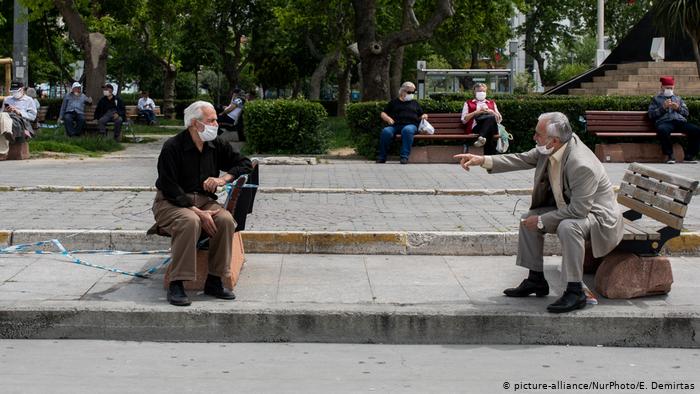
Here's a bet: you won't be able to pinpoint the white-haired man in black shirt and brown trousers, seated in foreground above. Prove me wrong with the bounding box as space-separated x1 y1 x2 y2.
153 101 252 306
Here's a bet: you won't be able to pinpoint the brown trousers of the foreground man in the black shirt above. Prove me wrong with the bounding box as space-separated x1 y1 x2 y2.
153 191 236 281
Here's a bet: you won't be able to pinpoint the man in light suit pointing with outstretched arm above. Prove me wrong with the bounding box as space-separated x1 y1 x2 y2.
455 112 624 313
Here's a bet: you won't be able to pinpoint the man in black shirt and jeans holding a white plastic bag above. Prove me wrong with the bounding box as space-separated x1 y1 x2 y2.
377 82 428 164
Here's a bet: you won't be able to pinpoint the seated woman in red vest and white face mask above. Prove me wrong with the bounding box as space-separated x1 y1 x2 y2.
462 83 503 155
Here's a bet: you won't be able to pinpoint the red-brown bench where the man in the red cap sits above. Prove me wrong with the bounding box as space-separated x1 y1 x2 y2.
586 111 684 163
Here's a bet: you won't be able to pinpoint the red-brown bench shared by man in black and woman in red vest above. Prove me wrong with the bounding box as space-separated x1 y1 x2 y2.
395 112 498 163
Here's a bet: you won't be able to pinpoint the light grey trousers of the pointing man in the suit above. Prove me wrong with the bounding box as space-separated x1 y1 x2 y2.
516 207 591 282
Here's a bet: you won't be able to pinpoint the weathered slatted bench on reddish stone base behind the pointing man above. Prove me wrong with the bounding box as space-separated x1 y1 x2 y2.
595 163 700 298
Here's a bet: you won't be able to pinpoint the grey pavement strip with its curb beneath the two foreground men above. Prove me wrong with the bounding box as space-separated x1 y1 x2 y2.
0 254 700 347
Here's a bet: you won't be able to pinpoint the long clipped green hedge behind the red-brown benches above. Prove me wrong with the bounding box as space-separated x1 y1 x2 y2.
347 96 700 159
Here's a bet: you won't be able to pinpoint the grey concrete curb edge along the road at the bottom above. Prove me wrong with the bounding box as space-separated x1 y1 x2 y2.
0 301 700 348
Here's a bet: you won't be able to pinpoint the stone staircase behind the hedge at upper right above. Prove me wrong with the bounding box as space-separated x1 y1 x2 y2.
569 62 700 96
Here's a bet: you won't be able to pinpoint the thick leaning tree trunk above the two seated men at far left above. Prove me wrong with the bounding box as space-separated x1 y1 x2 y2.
54 0 108 100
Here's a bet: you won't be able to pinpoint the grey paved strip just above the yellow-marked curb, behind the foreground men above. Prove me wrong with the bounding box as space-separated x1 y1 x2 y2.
0 191 700 232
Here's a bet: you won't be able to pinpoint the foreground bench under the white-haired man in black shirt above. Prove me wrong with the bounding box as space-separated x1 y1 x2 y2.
147 159 260 290
